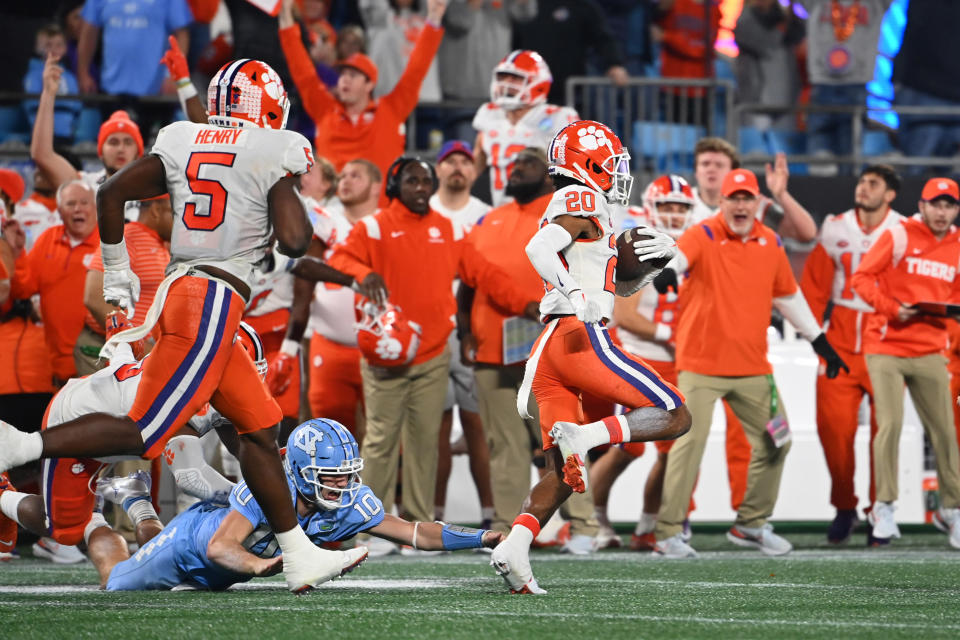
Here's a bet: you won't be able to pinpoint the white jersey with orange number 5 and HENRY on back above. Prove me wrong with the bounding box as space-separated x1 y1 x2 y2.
151 122 313 285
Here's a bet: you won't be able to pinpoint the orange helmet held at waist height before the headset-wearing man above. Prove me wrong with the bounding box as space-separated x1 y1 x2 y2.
356 302 421 367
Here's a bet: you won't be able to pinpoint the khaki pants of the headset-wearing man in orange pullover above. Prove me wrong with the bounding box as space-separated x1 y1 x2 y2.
360 350 450 522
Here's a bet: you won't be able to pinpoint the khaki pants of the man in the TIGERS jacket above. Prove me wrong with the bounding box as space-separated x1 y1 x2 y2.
866 353 960 508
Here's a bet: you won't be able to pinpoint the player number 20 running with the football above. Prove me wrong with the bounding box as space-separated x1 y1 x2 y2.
491 120 690 593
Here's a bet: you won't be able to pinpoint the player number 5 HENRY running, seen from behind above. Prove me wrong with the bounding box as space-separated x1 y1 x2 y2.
0 59 366 592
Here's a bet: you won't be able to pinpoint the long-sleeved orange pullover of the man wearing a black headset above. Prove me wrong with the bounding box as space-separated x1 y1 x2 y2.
329 200 524 364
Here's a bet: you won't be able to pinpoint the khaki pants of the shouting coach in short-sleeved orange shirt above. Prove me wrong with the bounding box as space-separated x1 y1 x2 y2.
656 371 790 540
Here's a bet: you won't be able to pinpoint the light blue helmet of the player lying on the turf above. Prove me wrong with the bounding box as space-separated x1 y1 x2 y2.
284 418 363 510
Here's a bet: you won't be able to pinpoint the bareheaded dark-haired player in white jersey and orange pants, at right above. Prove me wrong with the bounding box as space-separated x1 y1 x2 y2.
800 165 905 546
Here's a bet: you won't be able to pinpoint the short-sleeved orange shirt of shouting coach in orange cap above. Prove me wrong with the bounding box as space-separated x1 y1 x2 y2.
677 213 797 376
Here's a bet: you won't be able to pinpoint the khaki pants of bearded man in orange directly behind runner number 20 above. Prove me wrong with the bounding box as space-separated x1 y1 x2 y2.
474 365 597 536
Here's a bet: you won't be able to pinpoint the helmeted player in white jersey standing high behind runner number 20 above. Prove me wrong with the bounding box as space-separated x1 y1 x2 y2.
473 49 579 207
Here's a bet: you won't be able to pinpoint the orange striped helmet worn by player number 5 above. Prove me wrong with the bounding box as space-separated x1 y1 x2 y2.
207 58 290 129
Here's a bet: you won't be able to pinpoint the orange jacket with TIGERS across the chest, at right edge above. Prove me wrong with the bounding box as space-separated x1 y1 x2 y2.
851 217 960 358
